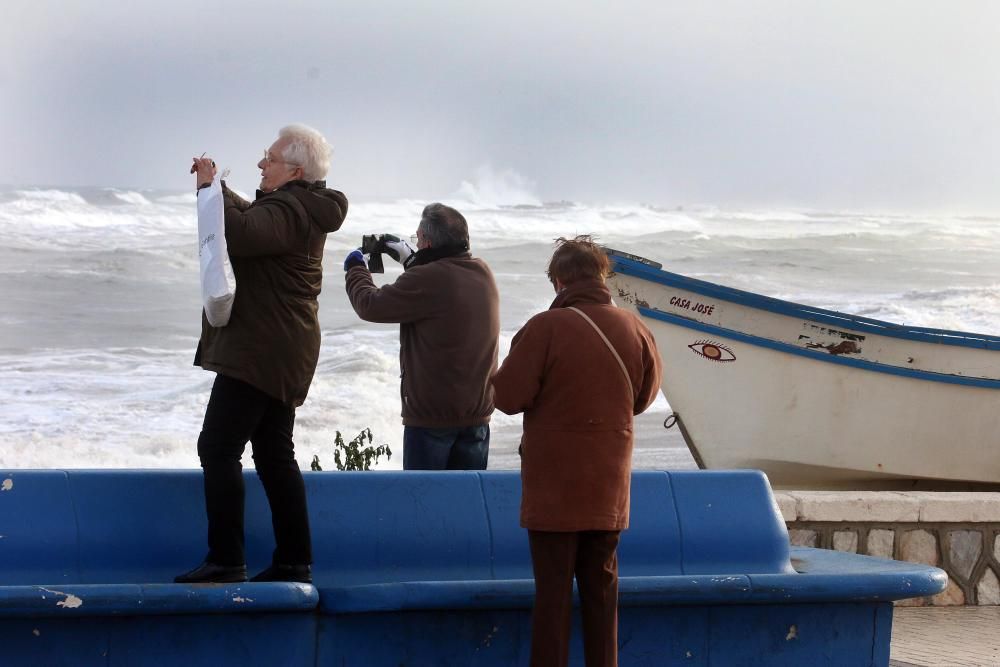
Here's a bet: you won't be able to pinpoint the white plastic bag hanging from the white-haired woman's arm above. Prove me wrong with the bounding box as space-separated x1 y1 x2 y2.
198 177 236 327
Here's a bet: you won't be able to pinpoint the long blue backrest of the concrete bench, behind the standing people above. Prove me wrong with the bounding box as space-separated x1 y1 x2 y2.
0 470 791 586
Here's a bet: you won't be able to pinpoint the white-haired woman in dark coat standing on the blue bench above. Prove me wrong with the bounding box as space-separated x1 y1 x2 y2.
175 125 347 583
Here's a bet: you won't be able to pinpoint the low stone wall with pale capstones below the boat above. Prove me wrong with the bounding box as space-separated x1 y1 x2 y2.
774 491 1000 606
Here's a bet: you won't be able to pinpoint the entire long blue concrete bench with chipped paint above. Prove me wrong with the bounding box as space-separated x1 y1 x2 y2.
0 471 946 665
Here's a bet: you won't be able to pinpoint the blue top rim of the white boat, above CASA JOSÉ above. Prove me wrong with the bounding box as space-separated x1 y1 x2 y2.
610 256 1000 350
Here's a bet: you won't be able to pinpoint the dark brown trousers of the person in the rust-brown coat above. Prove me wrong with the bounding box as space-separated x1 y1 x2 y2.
528 530 621 667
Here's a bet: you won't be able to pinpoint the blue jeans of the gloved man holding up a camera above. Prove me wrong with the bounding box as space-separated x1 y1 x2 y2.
403 424 490 470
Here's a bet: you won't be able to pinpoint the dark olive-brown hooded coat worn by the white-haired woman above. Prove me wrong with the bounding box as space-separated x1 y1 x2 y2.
194 181 347 407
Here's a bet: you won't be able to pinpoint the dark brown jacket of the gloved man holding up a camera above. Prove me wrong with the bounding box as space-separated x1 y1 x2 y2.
346 253 500 428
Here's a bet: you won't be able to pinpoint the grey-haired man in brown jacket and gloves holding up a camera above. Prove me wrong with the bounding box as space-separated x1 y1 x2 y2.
344 204 500 470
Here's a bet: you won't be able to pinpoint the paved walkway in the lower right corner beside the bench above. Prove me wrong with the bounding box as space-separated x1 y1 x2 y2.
889 607 1000 667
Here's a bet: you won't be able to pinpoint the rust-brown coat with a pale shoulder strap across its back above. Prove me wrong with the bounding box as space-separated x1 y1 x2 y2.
493 281 660 532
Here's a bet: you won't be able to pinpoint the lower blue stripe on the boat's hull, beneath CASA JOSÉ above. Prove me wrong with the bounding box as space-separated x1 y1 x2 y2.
639 306 1000 389
